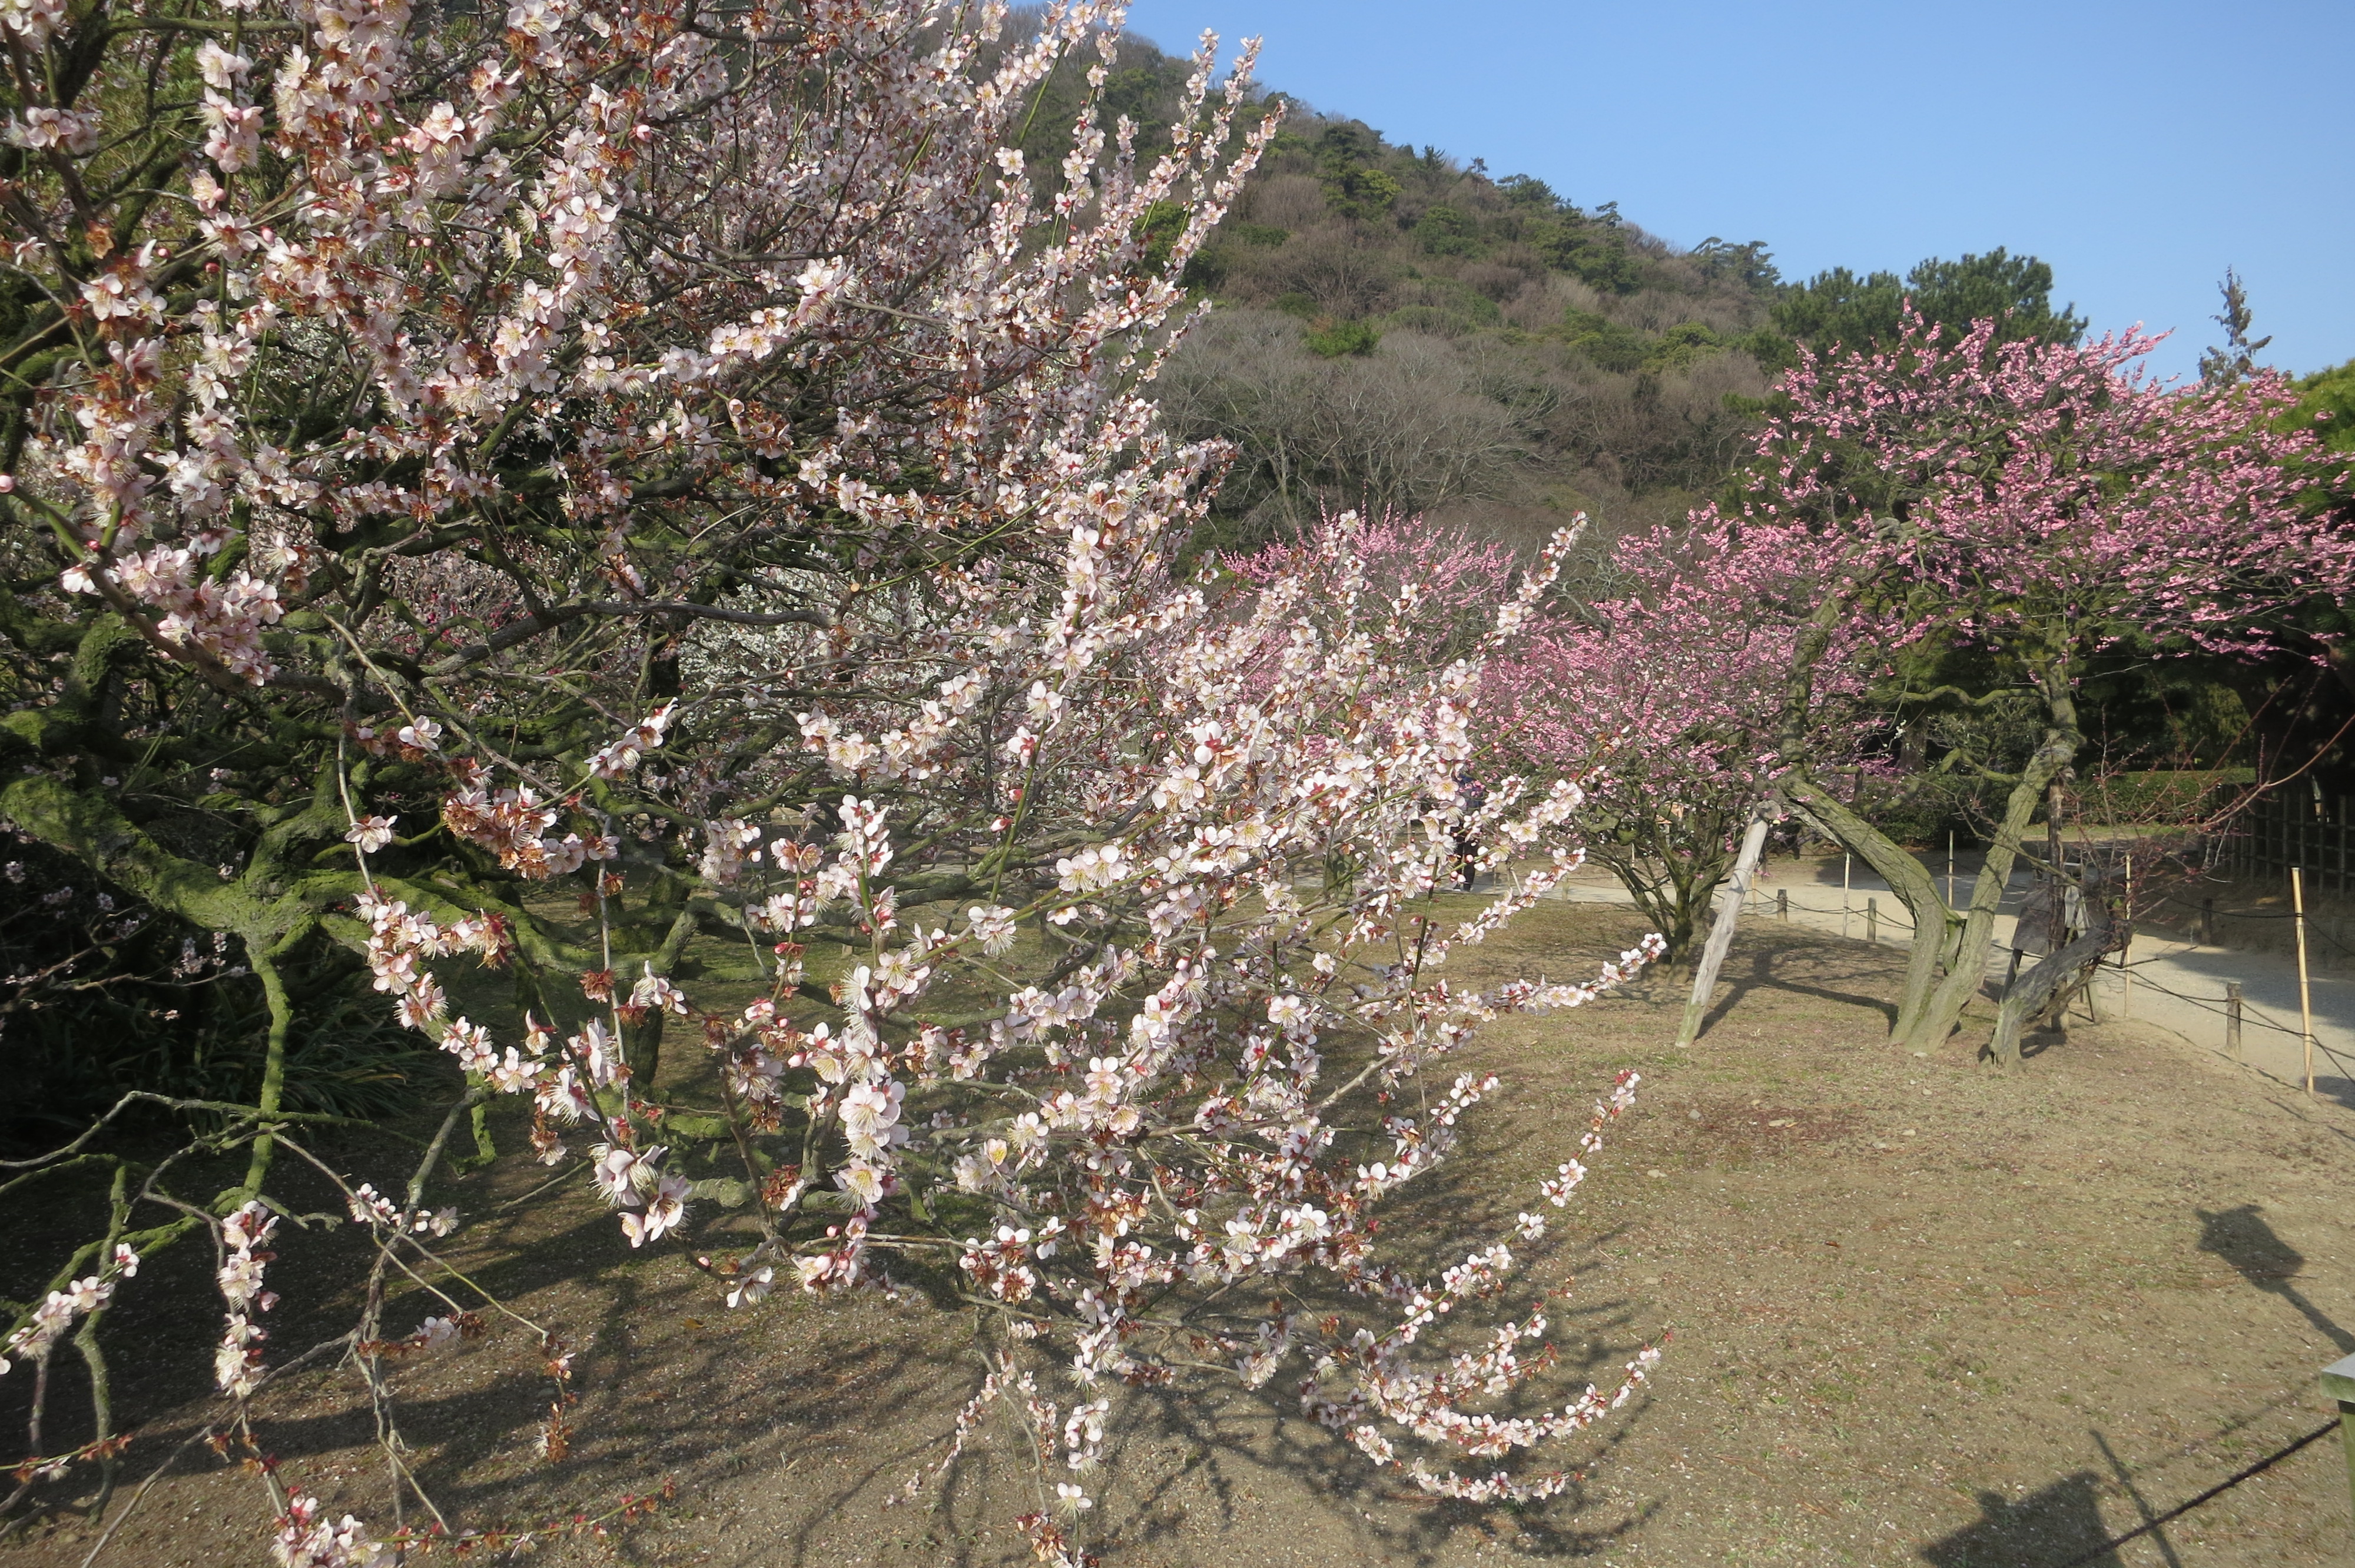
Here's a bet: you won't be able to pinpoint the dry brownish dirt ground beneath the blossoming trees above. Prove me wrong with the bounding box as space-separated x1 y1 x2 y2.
0 904 2355 1568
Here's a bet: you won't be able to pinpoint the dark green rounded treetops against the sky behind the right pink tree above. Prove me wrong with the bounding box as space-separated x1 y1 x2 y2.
1773 247 2087 351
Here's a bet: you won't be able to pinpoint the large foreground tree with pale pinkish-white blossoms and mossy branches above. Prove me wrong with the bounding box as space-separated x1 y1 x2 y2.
0 0 1651 1563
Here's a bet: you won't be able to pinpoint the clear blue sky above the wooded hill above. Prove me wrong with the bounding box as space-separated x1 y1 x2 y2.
1130 0 2355 374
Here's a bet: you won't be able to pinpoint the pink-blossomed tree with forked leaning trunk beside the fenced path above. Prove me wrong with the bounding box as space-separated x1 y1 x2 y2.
1724 318 2355 1055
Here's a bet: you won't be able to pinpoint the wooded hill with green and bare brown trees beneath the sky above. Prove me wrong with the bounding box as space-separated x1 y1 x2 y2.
1027 24 2084 544
